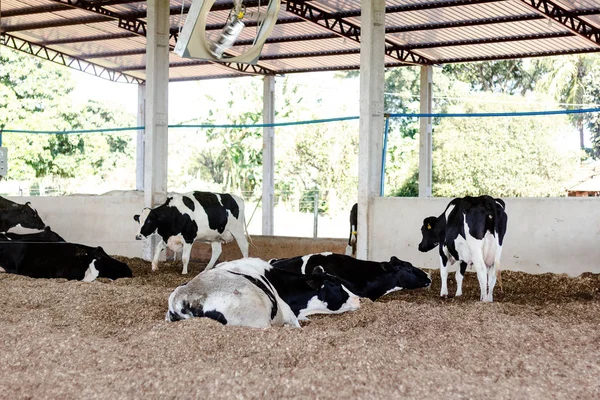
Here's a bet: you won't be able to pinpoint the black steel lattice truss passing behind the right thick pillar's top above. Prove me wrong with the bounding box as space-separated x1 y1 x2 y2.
286 0 432 65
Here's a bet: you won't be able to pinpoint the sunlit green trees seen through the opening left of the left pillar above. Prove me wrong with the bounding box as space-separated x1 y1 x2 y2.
0 49 135 187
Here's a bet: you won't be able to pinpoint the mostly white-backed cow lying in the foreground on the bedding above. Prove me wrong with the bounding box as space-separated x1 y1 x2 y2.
166 258 360 327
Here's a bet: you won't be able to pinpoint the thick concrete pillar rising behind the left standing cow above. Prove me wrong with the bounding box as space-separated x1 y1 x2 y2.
142 0 170 259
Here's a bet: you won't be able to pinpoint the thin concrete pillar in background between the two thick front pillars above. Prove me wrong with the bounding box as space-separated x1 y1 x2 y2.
262 76 275 236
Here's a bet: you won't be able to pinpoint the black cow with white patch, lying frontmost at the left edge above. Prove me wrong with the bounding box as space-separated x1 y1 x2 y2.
0 234 132 282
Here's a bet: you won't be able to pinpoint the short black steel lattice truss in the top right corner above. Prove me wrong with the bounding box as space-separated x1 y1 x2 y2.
521 0 600 47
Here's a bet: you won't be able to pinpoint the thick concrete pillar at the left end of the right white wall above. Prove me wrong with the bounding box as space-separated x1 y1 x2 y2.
356 0 385 259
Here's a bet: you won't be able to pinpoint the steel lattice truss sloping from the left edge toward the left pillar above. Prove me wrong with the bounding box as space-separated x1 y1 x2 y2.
0 33 144 83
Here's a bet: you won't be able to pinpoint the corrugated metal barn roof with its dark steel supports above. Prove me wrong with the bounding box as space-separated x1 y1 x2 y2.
0 0 600 82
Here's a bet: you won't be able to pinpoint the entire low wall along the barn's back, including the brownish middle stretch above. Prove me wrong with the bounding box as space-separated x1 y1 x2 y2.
10 191 600 276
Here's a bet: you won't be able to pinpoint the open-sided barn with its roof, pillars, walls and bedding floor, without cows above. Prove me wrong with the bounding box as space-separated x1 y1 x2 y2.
0 0 600 399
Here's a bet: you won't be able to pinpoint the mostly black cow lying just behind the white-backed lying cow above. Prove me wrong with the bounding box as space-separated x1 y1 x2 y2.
270 253 431 300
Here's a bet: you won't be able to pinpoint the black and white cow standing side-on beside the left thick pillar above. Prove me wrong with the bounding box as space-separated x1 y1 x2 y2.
133 192 248 274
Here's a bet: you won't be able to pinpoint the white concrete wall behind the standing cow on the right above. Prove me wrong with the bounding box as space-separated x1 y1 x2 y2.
370 197 600 276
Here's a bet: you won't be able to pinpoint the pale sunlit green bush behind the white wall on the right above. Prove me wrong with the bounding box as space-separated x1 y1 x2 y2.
433 95 578 197
